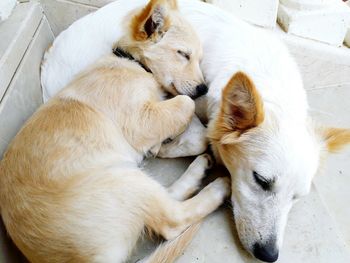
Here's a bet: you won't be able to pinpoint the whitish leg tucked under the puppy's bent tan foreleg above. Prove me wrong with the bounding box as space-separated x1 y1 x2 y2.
158 115 208 158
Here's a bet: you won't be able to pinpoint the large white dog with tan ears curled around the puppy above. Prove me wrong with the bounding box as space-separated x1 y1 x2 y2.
42 0 350 262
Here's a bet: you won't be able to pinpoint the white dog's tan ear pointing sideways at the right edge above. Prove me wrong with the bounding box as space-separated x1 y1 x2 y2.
317 128 350 153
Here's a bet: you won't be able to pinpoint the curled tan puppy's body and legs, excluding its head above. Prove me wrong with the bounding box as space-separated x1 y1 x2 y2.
0 1 229 263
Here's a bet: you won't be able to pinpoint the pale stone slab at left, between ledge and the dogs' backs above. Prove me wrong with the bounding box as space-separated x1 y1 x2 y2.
0 18 54 155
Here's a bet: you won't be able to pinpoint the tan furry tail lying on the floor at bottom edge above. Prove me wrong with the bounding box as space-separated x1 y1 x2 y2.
139 222 201 263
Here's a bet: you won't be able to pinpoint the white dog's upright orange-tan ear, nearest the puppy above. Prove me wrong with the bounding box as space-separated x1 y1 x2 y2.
216 72 264 144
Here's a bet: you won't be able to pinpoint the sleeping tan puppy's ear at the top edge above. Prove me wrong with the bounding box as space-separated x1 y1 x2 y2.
131 0 177 41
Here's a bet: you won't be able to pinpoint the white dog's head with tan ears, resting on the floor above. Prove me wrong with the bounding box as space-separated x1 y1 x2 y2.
209 73 350 262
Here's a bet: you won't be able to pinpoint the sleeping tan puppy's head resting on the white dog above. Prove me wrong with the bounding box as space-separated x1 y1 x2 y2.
117 0 208 98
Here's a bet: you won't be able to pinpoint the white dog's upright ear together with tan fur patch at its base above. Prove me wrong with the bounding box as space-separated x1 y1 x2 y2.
208 72 264 163
